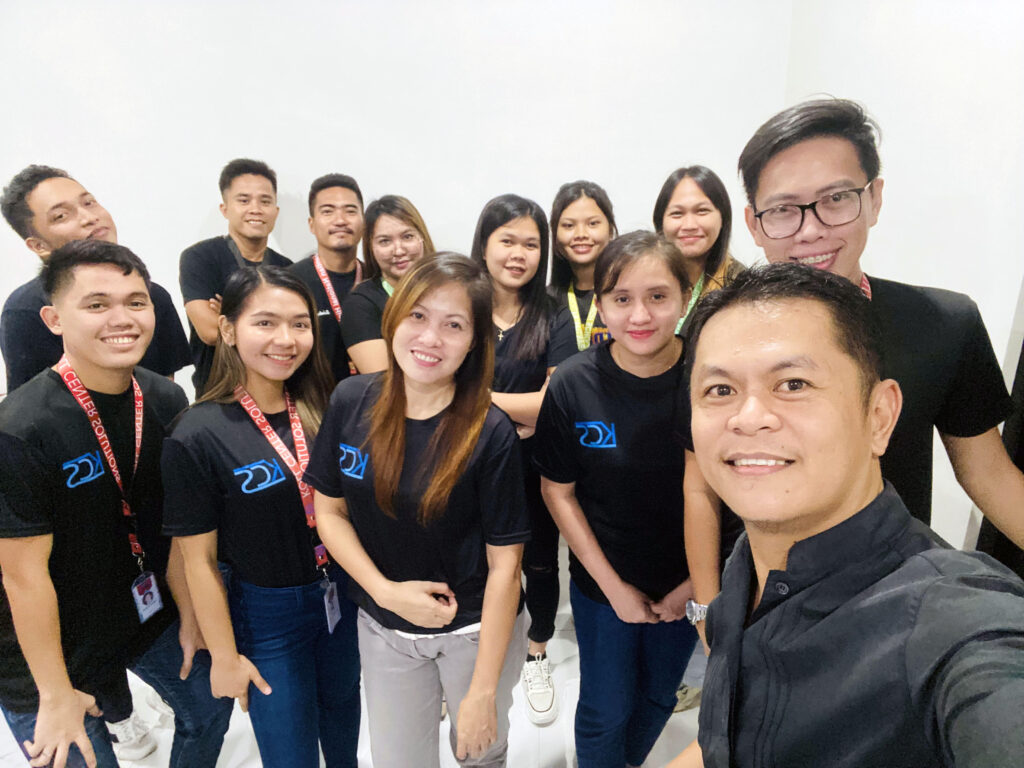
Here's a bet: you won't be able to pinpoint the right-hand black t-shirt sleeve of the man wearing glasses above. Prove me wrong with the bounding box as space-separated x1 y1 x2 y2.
935 299 1013 437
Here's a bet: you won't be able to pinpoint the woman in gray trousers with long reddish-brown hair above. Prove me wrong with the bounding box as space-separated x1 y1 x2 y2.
305 253 529 768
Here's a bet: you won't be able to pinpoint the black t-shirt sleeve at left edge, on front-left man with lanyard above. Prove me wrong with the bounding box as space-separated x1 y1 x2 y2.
0 433 59 539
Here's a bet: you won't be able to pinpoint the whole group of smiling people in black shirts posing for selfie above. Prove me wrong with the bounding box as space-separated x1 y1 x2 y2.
0 99 1024 768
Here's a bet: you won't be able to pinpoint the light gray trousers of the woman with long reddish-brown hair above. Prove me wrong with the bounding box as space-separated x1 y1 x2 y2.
357 609 529 768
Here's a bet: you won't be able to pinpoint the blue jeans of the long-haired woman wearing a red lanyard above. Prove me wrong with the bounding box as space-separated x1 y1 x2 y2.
229 565 359 768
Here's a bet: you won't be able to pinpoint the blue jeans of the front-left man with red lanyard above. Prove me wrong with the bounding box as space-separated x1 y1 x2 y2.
4 622 233 768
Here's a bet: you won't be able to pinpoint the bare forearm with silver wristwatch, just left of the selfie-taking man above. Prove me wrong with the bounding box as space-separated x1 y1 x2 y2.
683 452 722 605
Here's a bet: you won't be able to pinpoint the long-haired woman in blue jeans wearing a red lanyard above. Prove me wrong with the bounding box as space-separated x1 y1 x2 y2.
162 267 359 768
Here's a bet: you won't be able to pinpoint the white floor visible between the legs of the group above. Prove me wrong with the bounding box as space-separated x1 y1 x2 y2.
0 544 697 768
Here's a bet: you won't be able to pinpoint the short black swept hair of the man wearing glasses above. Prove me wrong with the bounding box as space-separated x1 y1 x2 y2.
739 98 882 207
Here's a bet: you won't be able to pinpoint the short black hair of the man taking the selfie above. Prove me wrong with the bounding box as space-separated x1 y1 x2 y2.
686 263 882 402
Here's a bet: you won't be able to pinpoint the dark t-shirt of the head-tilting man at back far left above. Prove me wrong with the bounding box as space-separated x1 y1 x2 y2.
0 278 193 392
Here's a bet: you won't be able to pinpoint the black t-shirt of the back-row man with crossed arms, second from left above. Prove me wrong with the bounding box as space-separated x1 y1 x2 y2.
178 234 292 397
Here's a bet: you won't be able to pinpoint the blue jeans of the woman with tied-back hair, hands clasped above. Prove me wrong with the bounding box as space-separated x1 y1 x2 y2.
569 583 697 768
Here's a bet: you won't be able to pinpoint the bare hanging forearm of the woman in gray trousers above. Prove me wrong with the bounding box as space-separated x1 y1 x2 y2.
469 545 522 695
